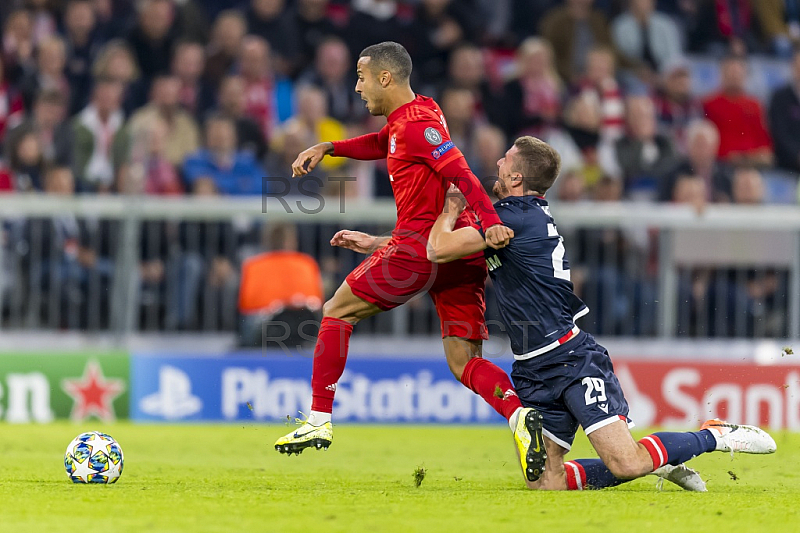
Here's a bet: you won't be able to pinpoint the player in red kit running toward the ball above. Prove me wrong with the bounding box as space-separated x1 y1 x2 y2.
275 42 544 479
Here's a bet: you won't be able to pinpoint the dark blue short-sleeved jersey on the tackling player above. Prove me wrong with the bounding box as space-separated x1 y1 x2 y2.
485 196 589 359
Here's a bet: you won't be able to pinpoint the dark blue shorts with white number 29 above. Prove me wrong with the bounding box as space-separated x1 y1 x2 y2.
511 331 633 450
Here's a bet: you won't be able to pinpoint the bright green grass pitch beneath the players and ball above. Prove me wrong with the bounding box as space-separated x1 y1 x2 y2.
0 423 800 533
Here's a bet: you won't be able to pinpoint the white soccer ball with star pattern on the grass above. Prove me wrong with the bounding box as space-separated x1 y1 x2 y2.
64 431 123 483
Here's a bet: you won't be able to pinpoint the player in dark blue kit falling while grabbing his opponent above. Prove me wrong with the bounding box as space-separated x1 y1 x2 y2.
428 137 776 490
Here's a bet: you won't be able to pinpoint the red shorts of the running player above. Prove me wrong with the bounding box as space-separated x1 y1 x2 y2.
345 246 488 340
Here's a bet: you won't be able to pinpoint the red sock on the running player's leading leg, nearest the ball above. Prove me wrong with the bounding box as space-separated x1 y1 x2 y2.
311 317 353 413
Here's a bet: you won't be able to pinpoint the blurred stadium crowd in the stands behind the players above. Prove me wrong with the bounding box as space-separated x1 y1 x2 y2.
0 0 800 332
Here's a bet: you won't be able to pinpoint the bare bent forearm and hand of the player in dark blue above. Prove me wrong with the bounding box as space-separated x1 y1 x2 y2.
428 185 486 263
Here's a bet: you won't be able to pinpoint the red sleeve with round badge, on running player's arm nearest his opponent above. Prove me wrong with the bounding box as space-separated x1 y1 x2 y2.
404 120 502 229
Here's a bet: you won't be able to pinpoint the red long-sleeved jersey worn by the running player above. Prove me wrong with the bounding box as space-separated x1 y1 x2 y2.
333 95 501 269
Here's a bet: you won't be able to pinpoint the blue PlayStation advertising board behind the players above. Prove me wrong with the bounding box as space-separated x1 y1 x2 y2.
130 354 508 423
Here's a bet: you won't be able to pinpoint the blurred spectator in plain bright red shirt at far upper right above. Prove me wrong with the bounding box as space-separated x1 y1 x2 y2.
703 56 773 166
